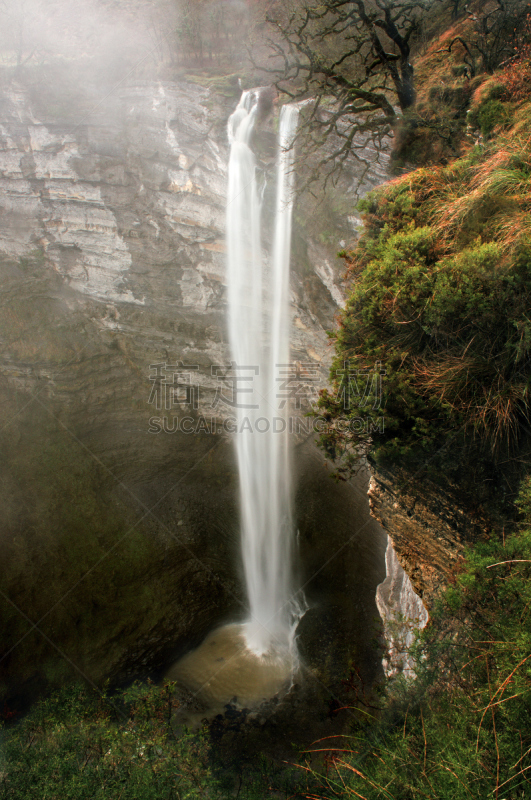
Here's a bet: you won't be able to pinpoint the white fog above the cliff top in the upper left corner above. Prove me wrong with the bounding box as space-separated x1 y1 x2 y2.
0 0 255 103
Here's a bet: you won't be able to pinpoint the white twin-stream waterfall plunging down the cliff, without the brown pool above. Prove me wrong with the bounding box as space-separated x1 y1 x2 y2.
227 91 302 655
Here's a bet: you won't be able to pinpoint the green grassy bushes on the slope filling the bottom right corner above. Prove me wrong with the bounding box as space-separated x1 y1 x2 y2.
300 479 531 800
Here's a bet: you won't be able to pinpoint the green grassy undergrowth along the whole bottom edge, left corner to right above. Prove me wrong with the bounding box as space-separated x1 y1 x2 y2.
4 478 531 800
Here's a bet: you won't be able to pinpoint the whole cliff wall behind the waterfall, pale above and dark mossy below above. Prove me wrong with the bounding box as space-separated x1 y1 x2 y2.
0 81 390 708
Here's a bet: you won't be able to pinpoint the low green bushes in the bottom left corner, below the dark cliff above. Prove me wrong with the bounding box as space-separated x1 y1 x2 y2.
0 684 213 800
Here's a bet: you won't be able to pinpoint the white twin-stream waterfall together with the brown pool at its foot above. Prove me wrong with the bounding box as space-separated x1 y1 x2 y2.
167 91 306 709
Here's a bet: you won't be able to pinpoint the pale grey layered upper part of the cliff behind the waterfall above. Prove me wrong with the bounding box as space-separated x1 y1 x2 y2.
0 82 362 418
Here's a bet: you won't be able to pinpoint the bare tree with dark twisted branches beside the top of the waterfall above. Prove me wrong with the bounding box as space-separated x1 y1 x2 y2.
255 0 429 183
